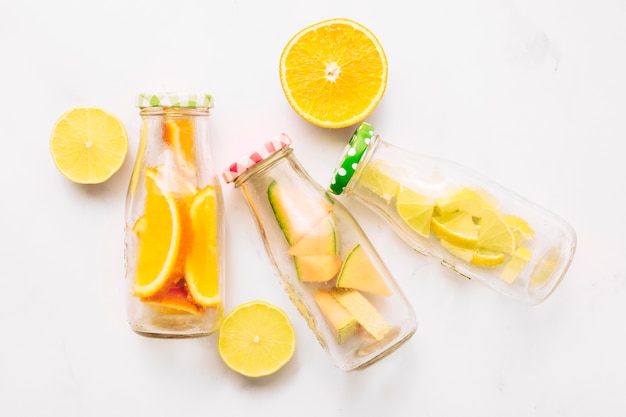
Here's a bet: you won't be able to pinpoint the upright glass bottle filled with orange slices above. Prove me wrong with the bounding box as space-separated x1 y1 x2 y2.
125 93 224 337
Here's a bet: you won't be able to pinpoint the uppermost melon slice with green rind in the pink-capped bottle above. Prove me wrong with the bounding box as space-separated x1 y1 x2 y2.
267 181 332 245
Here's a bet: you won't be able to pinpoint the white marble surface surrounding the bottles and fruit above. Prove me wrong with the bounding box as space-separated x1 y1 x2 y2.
0 0 626 417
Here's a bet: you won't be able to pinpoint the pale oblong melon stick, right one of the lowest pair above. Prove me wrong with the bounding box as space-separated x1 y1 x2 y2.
331 288 391 340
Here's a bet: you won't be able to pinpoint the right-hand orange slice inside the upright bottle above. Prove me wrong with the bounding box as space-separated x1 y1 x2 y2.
185 185 220 306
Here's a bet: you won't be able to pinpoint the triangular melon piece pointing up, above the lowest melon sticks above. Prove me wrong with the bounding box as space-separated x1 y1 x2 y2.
336 244 391 297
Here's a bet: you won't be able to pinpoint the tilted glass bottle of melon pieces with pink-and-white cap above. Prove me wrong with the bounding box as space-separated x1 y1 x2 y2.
223 134 417 371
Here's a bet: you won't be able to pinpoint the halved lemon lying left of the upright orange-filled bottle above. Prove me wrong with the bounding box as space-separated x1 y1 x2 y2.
50 107 128 184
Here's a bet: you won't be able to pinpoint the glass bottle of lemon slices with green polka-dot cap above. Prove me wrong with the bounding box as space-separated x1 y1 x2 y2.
329 123 576 304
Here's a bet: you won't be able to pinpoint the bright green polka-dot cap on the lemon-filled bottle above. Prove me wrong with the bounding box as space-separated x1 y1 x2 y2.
328 123 374 195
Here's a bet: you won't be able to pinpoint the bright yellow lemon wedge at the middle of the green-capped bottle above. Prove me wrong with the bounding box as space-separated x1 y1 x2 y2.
430 211 478 249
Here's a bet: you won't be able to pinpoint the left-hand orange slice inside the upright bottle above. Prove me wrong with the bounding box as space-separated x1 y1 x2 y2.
133 169 182 298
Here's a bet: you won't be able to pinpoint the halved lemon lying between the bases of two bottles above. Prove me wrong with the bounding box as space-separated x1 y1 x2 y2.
218 301 296 377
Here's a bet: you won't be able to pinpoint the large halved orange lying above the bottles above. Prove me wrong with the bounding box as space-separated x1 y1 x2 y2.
280 18 388 128
